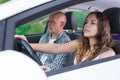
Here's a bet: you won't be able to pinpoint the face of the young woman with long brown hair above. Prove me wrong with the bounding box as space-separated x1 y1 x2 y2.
83 14 98 38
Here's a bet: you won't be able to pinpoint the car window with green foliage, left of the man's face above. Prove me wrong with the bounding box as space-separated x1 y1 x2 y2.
15 16 48 35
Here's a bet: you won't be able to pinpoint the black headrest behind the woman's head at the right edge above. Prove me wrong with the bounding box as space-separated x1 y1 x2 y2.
103 7 120 34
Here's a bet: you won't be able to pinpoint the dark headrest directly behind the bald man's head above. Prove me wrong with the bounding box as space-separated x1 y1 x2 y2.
64 12 77 30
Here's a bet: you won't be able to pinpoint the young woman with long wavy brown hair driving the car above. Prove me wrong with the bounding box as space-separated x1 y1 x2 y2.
16 12 115 64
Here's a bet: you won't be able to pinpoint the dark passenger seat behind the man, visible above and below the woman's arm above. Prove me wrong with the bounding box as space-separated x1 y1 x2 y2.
63 12 81 67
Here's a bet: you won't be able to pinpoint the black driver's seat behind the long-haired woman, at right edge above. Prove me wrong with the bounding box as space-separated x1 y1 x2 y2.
103 7 120 54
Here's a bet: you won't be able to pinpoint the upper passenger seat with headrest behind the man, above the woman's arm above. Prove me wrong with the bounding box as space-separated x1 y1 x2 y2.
64 12 82 40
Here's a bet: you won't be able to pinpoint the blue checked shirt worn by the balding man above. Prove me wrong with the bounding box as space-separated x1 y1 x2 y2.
37 32 71 70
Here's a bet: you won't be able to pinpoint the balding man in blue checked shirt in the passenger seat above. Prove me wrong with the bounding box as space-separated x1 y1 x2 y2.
37 12 70 71
